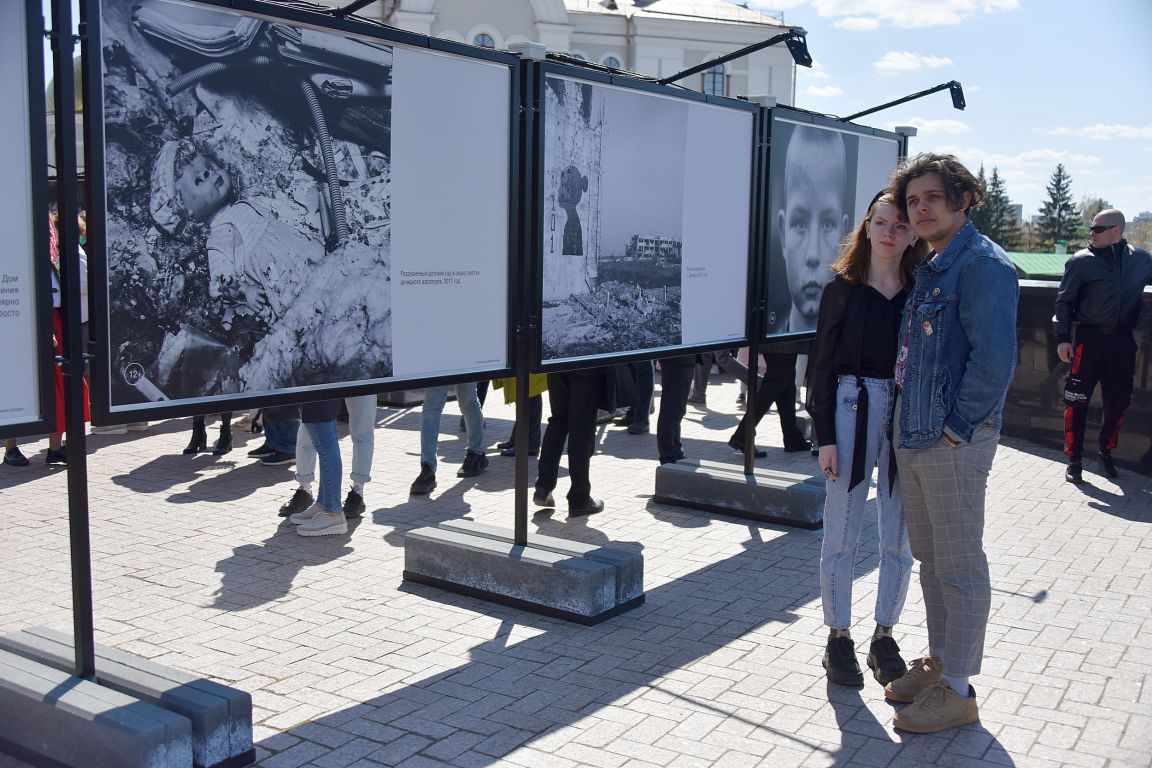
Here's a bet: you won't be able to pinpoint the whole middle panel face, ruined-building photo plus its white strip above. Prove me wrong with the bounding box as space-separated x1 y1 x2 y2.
540 75 755 366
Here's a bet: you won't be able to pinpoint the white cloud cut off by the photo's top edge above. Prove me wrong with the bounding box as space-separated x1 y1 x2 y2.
749 0 1020 32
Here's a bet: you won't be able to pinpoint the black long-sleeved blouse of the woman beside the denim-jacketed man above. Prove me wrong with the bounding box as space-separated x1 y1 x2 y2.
806 275 908 446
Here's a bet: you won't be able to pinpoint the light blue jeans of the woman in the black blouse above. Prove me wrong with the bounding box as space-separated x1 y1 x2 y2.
820 375 912 630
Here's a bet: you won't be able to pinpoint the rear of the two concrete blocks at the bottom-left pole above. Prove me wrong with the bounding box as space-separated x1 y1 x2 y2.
0 626 256 768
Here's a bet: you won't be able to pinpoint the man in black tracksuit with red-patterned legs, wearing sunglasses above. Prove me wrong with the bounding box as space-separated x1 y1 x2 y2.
1055 208 1152 484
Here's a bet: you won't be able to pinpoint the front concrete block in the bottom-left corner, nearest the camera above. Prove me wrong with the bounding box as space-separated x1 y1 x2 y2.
0 651 192 768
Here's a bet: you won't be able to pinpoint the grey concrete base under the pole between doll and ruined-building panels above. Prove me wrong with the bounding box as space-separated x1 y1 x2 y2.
404 520 644 624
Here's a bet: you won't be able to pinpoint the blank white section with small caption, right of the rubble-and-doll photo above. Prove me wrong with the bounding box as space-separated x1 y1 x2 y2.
392 46 511 378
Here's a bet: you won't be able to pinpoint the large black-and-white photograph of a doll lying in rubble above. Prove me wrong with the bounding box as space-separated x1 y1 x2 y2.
100 0 393 408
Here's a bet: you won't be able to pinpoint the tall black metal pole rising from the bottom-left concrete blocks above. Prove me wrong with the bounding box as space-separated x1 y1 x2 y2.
50 0 96 679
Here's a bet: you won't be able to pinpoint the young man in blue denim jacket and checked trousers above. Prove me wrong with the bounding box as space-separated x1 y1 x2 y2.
885 154 1020 733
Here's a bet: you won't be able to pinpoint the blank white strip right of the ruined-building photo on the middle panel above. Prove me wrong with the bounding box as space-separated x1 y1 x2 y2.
681 102 753 345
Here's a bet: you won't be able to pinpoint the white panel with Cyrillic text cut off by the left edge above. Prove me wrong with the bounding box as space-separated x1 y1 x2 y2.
0 0 42 425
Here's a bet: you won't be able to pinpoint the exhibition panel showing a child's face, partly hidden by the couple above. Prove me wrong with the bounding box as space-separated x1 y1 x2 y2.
766 117 899 336
